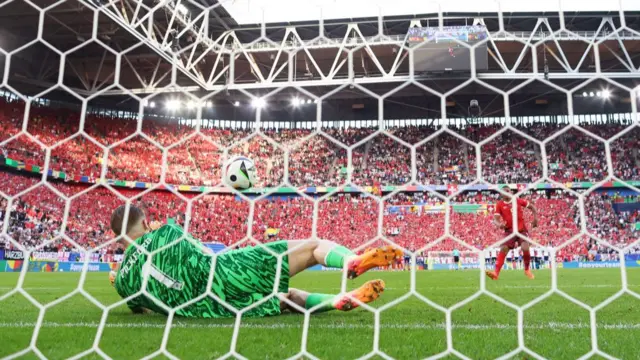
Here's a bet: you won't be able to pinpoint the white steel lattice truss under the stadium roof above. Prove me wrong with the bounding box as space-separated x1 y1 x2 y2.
5 0 640 96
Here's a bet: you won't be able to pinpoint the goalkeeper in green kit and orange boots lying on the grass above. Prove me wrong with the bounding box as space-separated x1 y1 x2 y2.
109 206 402 318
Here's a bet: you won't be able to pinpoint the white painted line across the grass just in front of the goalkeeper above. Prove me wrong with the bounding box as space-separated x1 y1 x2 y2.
0 322 640 330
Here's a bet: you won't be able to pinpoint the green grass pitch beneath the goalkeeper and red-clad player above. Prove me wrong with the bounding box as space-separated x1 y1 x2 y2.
0 269 640 359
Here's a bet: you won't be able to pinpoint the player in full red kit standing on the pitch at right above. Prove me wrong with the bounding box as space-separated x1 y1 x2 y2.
487 186 538 280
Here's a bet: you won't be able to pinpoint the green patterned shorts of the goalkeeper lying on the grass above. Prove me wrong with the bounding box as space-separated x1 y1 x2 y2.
211 241 289 317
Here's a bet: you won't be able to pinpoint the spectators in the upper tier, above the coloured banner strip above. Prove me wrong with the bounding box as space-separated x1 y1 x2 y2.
0 99 640 187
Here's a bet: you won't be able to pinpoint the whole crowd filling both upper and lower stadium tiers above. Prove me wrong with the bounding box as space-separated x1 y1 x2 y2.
0 95 640 257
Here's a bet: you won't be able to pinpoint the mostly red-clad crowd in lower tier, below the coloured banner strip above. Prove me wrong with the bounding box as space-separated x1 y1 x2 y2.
0 172 640 256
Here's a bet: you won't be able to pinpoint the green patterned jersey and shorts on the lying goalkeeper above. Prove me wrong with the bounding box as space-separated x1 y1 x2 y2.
115 224 289 318
